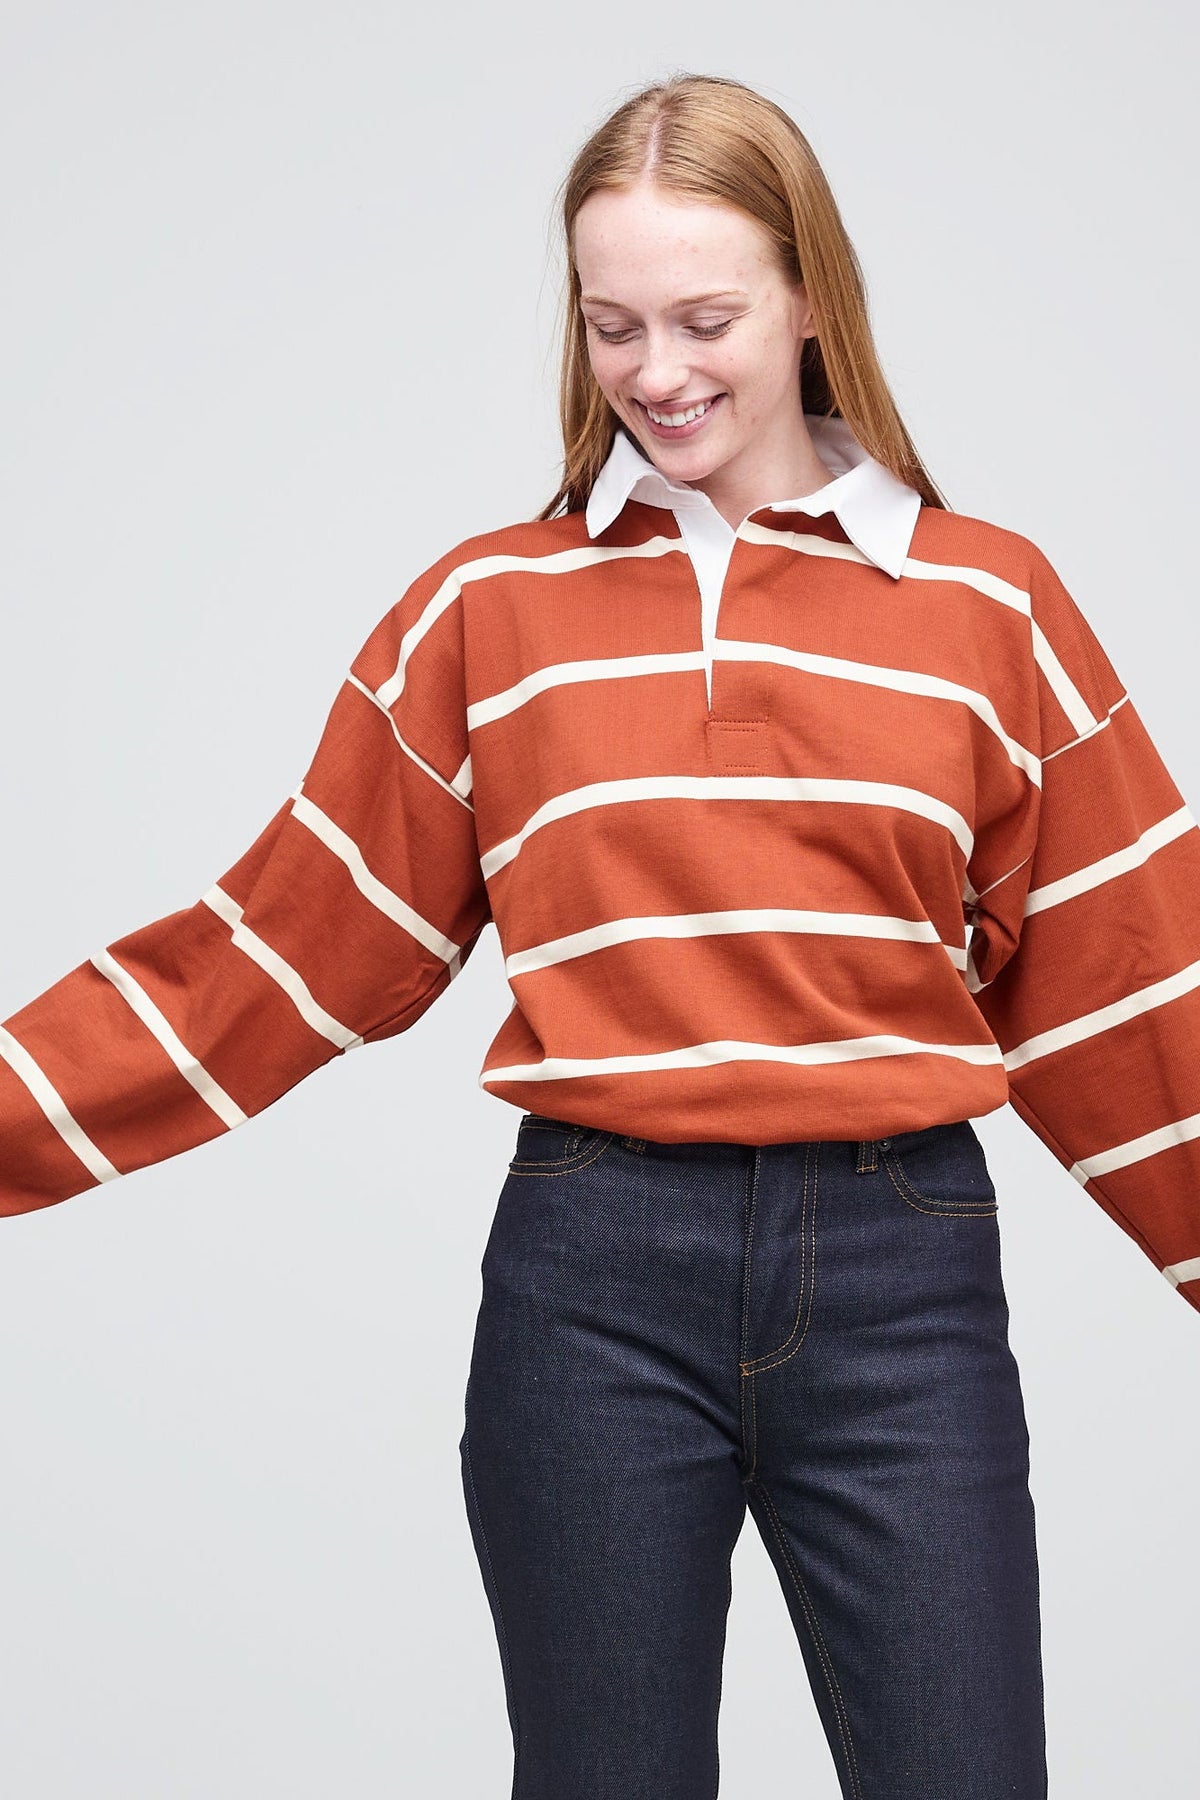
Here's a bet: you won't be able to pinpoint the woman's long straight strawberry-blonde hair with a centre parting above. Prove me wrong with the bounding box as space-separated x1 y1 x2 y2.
536 74 948 518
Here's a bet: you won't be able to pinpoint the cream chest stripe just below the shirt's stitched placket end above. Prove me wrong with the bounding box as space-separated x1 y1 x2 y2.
480 776 973 877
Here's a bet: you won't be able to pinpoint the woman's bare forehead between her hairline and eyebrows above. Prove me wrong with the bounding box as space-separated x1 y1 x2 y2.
574 185 779 299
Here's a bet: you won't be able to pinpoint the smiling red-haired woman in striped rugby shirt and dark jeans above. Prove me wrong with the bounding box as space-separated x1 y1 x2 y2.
0 77 1200 1800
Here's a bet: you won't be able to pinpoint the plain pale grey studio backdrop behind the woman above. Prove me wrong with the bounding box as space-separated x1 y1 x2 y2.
0 0 1200 1800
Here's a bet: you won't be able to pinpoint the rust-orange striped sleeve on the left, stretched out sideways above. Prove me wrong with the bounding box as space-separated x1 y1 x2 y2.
0 565 489 1213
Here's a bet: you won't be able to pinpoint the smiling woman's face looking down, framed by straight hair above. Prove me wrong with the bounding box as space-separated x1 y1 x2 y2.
574 182 815 504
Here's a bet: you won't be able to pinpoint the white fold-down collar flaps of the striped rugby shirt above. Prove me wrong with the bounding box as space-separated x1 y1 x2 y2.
585 412 921 578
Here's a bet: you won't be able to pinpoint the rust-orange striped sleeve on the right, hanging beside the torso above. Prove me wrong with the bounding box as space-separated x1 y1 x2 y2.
968 551 1200 1309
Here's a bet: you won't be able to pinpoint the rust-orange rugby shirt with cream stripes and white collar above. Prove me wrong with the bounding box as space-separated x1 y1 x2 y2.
0 421 1200 1307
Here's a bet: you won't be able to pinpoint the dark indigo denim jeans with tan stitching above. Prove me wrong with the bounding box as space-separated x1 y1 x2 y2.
459 1112 1047 1800
